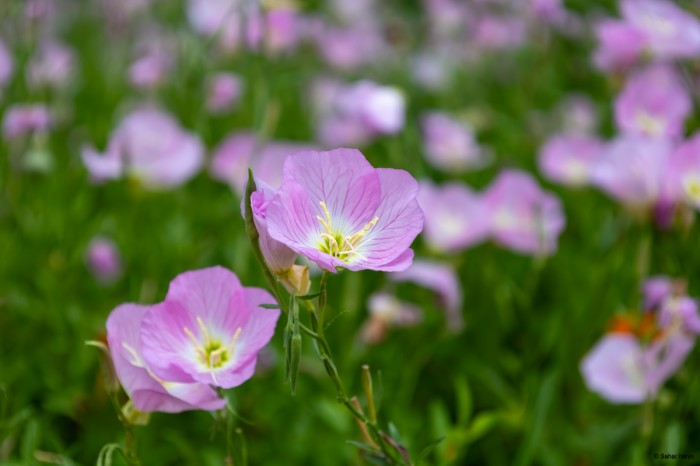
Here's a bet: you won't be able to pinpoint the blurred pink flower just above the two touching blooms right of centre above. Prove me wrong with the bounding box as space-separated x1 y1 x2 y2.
421 112 487 173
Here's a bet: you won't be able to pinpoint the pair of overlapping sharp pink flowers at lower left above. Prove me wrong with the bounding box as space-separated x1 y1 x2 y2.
107 267 280 412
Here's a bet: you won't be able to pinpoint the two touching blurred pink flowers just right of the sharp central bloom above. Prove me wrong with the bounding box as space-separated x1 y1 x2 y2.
418 170 566 255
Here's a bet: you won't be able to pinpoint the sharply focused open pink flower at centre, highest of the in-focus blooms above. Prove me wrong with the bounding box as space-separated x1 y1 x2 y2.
267 149 423 272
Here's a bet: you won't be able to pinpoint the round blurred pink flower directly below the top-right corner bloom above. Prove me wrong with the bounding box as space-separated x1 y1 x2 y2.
615 64 692 138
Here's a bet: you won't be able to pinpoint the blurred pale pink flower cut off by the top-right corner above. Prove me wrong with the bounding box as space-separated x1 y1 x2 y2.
620 0 700 60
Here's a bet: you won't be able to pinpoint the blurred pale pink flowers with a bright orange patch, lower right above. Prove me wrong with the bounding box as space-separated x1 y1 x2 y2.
581 277 700 403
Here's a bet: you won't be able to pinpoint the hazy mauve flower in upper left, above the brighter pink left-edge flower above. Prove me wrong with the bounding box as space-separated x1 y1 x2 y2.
27 40 75 88
